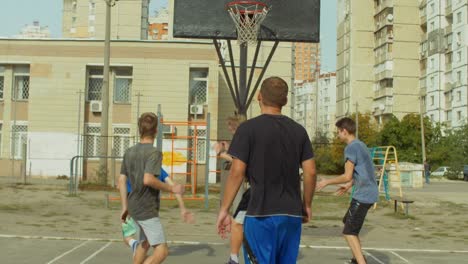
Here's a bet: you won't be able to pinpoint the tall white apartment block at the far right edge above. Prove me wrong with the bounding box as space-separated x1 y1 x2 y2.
419 0 468 128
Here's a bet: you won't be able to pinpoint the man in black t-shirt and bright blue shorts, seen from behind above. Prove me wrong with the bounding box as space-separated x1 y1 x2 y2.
217 77 316 264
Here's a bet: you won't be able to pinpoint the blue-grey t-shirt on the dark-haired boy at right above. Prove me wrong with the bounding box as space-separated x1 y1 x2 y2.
345 139 379 204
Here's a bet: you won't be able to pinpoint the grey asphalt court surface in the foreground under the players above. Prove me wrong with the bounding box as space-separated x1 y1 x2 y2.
0 235 468 264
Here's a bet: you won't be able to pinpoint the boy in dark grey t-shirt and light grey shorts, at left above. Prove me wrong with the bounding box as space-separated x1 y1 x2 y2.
119 113 184 263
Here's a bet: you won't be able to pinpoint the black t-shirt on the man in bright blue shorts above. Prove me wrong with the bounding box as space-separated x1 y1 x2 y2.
228 114 314 216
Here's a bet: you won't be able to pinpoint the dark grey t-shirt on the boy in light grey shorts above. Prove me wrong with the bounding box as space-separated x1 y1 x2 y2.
120 143 162 221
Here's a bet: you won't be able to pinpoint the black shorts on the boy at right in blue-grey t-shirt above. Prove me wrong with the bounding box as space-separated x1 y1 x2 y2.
343 199 373 236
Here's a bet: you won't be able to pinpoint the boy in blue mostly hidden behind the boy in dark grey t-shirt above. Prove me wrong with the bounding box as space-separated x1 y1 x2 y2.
122 168 194 252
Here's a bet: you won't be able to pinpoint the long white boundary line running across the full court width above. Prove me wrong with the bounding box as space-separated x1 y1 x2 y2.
0 234 468 254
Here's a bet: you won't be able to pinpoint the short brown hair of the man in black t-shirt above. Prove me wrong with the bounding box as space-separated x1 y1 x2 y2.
260 76 288 108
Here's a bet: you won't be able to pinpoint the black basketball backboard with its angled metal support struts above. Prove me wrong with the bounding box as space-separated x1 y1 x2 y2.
172 0 320 116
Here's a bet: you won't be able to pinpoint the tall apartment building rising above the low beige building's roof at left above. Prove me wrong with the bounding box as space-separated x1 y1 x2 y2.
62 0 149 40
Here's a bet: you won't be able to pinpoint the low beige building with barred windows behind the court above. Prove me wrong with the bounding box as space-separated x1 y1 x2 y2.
0 39 291 183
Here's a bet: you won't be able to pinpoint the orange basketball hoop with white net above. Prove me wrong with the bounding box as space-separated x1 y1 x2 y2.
226 1 270 44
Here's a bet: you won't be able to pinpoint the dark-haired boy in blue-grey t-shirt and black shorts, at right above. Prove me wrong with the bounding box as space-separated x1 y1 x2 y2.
316 117 379 264
